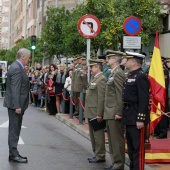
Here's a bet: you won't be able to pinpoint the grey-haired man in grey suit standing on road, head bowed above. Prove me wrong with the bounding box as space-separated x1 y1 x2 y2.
4 48 31 163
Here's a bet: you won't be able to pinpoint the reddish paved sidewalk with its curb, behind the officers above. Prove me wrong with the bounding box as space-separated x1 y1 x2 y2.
56 113 170 170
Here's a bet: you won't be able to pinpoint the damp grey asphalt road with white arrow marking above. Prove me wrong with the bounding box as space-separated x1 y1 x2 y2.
0 99 128 170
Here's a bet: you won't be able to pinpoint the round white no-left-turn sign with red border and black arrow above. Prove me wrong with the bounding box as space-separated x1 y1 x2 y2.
77 14 101 38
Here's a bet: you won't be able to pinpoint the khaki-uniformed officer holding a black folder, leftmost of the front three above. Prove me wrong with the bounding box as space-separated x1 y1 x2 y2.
84 59 106 163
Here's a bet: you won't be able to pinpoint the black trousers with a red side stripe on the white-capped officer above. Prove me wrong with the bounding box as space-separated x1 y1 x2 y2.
126 126 145 170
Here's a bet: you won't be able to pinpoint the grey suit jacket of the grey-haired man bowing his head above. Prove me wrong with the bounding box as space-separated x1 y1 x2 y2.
4 61 29 111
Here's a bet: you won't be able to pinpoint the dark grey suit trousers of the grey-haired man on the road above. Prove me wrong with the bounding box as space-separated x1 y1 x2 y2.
8 109 23 156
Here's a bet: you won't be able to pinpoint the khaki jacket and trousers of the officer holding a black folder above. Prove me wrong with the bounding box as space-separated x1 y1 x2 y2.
84 73 106 160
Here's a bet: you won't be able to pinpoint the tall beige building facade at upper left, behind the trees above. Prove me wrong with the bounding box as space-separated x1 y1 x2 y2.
8 0 84 48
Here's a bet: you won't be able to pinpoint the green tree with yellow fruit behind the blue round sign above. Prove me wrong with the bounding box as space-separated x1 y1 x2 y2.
87 0 163 49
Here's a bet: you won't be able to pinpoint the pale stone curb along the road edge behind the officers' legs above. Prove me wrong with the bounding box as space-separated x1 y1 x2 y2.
55 113 154 170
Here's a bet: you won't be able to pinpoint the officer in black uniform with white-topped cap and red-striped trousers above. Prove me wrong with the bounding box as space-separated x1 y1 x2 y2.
122 52 150 170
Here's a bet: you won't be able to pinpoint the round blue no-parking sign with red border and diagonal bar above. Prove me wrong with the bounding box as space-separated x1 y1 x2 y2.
123 16 142 36
